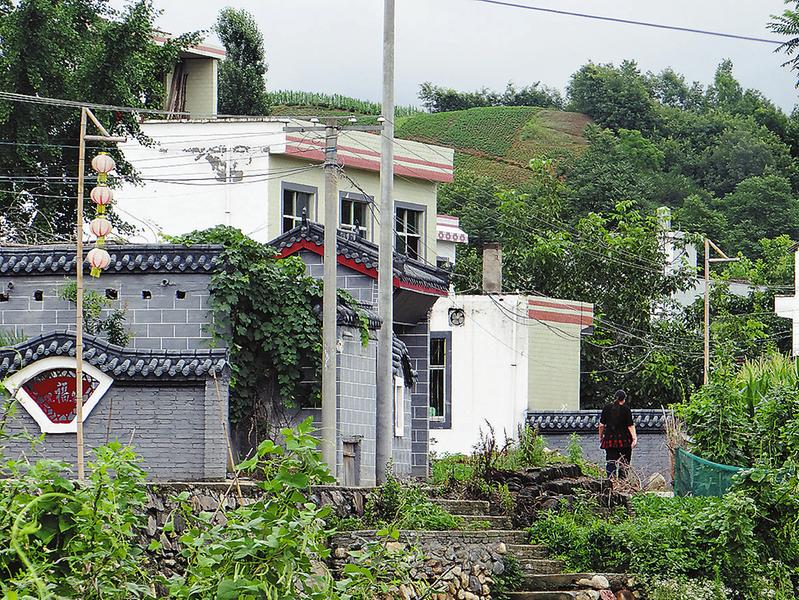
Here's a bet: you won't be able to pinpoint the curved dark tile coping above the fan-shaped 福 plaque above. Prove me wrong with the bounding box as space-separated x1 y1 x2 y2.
0 331 228 380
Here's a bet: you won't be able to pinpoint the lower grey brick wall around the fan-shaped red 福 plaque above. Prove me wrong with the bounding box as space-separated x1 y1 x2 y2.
4 380 227 481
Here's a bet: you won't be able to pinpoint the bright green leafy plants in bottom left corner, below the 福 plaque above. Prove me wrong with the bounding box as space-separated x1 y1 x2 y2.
0 443 153 600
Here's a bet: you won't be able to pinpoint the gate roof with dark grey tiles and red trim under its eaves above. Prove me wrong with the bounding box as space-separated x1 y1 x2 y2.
270 221 449 296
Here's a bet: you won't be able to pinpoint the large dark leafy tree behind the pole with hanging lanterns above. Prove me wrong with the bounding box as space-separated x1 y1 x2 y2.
0 0 196 243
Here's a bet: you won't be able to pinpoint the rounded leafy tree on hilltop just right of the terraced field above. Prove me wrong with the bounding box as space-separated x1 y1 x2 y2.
568 61 656 131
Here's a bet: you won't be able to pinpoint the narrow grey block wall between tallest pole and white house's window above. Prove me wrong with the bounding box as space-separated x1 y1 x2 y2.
395 319 430 477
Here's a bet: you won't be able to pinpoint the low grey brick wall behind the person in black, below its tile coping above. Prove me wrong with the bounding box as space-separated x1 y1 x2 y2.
542 431 671 483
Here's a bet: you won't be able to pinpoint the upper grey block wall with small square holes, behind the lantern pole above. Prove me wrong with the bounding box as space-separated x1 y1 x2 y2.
0 273 212 350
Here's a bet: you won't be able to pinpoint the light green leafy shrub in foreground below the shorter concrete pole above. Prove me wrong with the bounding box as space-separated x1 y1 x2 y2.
169 418 335 600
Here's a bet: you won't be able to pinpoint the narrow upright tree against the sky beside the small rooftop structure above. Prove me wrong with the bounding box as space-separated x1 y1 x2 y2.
215 7 269 115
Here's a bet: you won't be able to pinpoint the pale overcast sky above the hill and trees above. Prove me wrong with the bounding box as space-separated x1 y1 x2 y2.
139 0 797 110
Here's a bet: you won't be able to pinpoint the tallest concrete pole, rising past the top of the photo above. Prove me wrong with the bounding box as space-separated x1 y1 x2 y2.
375 0 394 484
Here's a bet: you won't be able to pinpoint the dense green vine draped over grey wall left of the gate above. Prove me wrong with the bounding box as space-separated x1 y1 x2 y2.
169 226 369 437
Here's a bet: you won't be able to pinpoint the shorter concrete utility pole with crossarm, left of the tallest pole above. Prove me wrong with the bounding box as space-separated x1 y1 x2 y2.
283 117 383 477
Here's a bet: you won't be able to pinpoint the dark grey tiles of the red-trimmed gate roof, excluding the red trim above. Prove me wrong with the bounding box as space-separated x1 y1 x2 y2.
269 221 449 291
